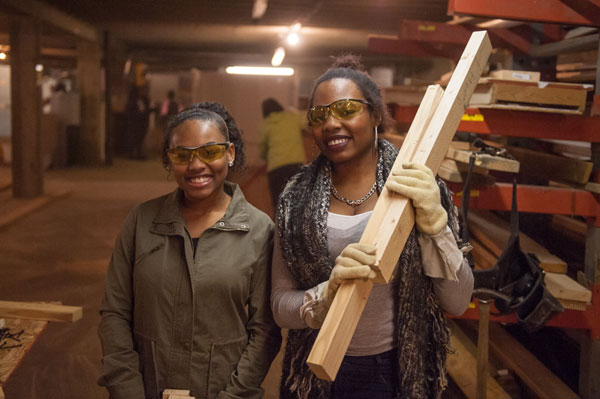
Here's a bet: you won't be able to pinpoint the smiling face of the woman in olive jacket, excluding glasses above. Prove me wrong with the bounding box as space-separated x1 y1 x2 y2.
170 119 235 202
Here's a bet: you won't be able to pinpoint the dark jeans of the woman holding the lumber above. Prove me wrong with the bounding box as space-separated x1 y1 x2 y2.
333 349 398 399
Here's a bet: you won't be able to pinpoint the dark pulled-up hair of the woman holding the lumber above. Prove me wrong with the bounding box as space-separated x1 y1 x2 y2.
308 54 391 131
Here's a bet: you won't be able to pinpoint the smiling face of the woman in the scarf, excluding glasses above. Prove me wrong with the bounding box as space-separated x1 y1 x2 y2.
311 78 375 164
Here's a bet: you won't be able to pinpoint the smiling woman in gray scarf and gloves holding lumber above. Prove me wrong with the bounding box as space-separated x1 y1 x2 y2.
271 56 473 399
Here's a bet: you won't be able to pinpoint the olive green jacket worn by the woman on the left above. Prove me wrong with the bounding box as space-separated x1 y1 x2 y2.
98 182 281 399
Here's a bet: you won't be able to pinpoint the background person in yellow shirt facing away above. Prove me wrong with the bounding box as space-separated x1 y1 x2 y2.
259 98 306 208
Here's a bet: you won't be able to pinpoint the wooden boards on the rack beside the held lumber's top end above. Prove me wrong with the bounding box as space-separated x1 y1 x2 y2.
469 70 593 114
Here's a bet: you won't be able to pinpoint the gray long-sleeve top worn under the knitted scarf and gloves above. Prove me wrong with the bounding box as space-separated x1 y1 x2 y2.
271 211 473 356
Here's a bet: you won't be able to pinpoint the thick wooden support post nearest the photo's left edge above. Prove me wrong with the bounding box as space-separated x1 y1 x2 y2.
10 15 44 198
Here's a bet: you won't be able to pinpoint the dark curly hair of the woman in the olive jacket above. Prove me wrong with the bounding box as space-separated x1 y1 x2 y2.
162 101 246 170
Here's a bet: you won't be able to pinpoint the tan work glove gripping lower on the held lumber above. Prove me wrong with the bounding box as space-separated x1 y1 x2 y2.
323 243 377 306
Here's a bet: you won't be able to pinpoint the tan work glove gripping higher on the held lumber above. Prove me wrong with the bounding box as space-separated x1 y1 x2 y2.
385 162 448 235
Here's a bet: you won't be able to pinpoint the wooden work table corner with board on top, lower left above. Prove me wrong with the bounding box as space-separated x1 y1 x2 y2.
0 301 82 399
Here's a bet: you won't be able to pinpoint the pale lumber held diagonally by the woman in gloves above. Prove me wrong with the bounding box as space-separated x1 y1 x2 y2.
307 31 492 381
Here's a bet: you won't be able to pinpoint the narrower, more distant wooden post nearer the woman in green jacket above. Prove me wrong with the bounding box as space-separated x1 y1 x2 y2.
75 39 105 165
